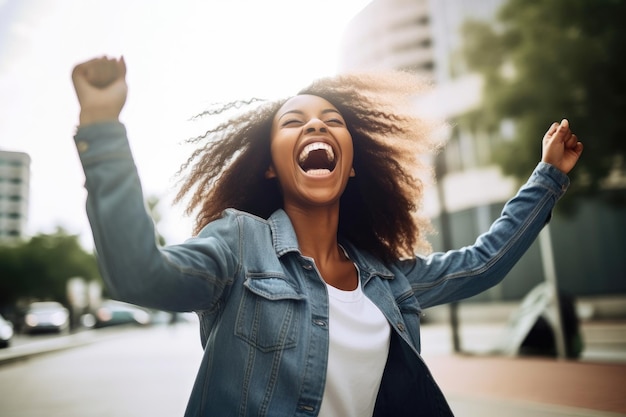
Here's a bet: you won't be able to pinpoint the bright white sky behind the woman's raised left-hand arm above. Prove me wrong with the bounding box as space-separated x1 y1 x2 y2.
0 0 369 247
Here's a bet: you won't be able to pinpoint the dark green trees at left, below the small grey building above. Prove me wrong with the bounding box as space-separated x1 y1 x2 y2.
0 229 101 306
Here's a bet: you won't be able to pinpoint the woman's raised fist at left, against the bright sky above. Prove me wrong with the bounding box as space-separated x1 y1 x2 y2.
72 57 128 126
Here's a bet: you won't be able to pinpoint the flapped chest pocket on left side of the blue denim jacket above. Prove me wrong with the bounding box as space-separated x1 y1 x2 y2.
235 274 304 352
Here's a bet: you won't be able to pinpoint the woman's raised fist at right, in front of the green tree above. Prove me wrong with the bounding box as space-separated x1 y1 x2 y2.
541 119 583 174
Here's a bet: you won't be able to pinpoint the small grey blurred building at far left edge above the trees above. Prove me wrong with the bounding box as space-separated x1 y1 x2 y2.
0 150 30 244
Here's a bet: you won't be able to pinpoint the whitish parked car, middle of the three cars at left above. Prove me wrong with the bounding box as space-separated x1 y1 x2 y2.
22 301 70 333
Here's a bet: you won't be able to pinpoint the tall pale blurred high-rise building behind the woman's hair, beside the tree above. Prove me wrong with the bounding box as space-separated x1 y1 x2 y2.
339 0 514 214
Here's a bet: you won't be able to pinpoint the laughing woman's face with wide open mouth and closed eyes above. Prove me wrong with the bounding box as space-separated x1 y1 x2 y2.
266 95 354 208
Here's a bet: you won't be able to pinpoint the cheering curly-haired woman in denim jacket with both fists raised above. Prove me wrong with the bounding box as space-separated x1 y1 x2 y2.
73 58 582 417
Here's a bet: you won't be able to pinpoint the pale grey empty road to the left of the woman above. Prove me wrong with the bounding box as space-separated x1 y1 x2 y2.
0 323 202 417
